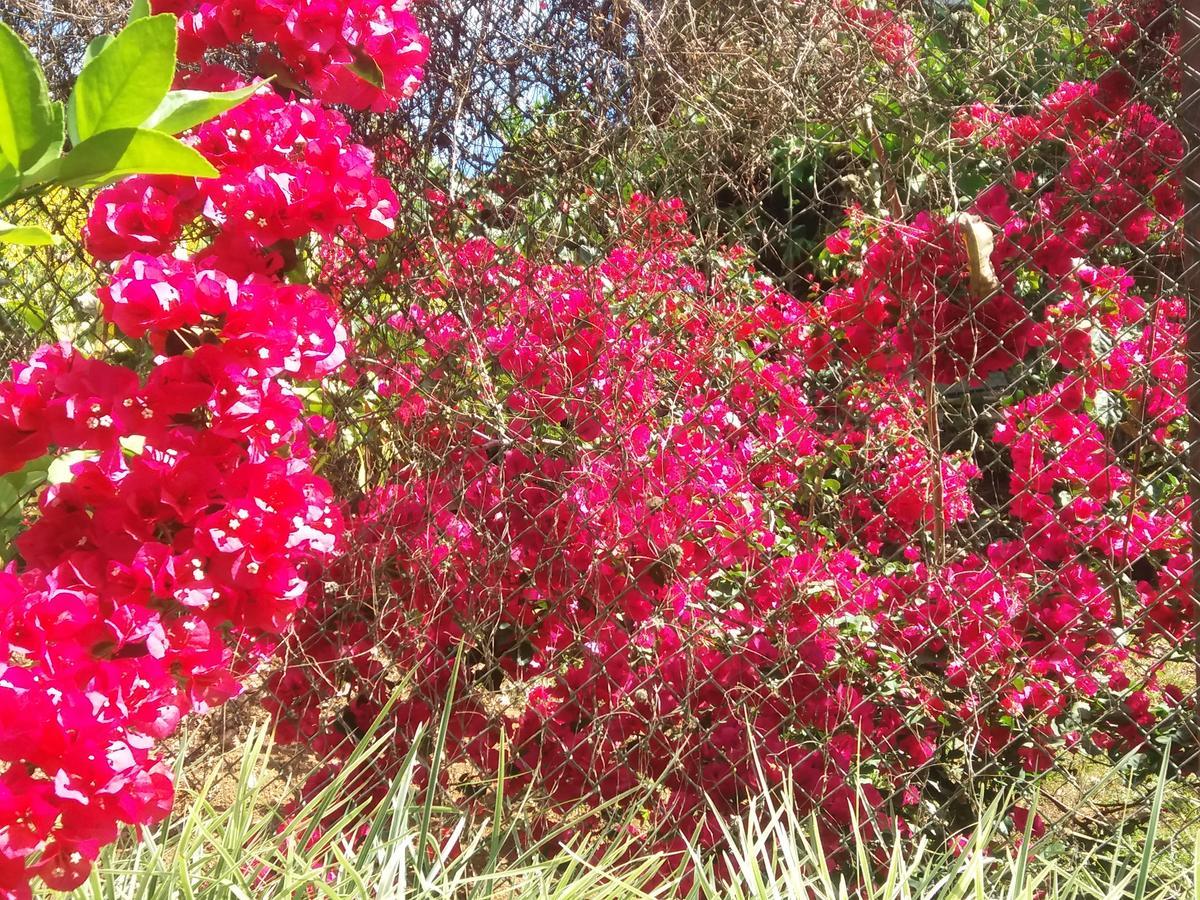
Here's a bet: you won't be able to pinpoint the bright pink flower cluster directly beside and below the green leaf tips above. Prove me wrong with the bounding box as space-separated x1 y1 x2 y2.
84 81 397 267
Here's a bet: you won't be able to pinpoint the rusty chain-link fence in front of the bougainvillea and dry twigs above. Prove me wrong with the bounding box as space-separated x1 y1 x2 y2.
0 0 1200 892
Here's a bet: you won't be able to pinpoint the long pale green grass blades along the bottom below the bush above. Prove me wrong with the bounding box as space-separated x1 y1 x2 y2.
43 724 1200 900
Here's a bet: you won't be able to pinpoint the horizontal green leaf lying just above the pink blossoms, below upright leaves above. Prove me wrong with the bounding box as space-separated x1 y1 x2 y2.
48 127 217 187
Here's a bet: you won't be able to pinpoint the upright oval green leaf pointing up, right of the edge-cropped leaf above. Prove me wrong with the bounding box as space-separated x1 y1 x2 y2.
67 13 175 144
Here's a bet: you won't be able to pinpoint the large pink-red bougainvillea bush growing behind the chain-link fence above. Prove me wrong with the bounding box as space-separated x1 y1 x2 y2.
260 0 1195 868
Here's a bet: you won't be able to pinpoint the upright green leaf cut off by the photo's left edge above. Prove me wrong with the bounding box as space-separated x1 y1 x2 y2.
0 22 54 172
